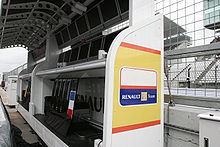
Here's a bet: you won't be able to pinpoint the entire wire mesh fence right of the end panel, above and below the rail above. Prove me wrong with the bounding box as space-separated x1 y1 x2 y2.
155 0 220 97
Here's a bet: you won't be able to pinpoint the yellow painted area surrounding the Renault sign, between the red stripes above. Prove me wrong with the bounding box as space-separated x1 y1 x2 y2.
112 47 161 128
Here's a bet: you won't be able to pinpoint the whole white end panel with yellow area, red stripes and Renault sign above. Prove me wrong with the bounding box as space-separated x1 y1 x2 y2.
102 15 164 147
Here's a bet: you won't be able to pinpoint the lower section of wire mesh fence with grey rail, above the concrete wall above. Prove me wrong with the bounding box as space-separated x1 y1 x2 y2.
164 43 220 97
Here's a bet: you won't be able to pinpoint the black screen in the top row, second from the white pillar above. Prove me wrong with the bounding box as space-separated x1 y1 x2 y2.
100 0 118 22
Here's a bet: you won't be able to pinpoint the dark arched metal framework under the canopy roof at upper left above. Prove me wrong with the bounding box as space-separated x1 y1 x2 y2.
0 0 94 49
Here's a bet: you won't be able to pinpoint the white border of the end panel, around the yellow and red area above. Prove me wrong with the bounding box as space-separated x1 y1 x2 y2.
103 15 163 147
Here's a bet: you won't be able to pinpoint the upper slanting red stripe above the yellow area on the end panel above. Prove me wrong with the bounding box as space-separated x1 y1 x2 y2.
120 42 161 55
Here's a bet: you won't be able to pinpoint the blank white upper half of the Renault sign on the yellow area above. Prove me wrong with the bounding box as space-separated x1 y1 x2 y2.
121 67 157 86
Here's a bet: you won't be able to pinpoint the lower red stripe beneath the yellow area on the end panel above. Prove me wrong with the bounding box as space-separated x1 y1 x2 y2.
112 120 160 134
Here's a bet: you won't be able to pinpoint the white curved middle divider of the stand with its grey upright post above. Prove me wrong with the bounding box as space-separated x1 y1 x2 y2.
29 33 59 115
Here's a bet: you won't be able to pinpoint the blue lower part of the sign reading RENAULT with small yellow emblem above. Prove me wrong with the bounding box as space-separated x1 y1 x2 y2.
120 89 157 106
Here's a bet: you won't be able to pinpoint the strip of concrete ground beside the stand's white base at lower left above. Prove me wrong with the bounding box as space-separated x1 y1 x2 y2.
0 88 43 144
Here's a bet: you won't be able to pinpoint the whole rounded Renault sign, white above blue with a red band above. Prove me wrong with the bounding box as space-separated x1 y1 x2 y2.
120 67 157 106
